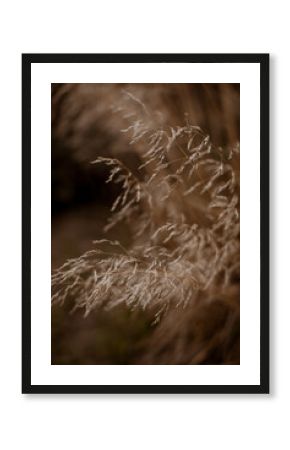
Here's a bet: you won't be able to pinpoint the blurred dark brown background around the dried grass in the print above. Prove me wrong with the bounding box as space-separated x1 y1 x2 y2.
51 84 240 364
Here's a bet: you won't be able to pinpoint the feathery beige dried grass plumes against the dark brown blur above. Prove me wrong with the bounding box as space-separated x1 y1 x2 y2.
52 92 240 322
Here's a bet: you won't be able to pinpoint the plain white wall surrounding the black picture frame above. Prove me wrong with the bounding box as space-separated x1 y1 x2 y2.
0 0 290 450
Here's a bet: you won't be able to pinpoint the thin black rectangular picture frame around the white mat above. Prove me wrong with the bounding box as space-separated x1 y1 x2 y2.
22 53 269 394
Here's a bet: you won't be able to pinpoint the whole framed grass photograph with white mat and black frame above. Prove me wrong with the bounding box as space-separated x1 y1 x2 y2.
22 54 269 394
